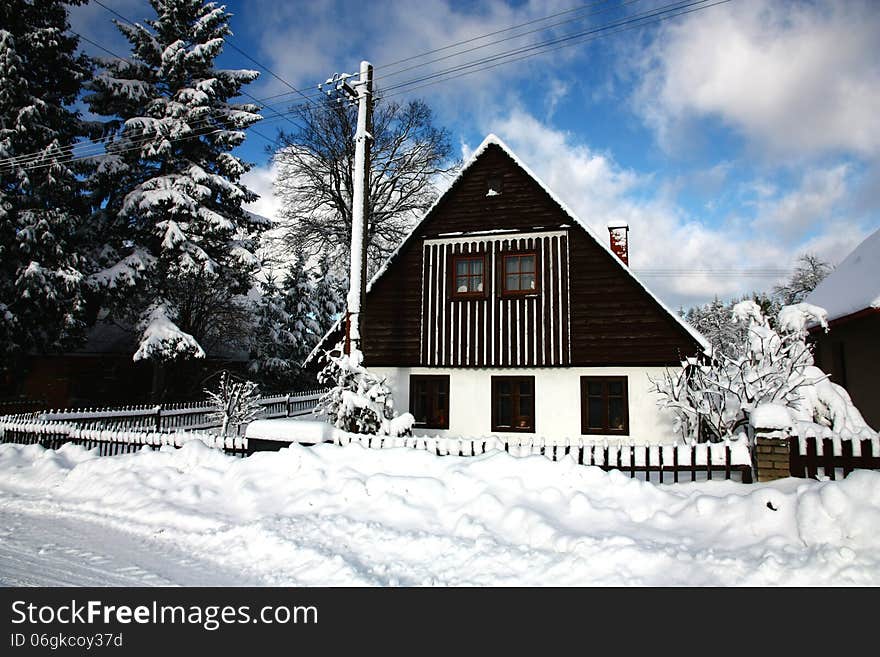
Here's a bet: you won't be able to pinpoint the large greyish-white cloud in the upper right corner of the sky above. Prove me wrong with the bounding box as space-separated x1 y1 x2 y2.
635 0 880 157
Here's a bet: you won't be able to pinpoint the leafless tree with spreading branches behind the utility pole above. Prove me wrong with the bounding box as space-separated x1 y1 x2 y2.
274 94 460 270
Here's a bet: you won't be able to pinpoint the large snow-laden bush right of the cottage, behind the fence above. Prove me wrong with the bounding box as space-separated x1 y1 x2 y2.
653 301 874 442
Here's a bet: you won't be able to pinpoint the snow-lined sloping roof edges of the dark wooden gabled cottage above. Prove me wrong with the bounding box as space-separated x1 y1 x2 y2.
305 134 710 364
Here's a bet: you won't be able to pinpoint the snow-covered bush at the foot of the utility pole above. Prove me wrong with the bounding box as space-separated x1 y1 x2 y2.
317 344 415 436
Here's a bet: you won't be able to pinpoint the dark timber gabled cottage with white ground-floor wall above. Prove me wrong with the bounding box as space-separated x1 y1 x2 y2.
310 135 707 442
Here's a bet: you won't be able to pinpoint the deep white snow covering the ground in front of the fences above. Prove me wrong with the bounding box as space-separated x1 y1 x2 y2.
0 441 880 586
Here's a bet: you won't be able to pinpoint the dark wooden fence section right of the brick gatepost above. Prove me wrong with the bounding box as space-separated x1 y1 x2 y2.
789 436 880 479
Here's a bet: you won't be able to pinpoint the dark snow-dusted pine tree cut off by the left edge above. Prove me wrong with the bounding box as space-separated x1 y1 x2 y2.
0 0 90 362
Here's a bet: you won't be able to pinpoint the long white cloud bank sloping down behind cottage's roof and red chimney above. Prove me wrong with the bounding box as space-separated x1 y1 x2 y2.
474 110 869 307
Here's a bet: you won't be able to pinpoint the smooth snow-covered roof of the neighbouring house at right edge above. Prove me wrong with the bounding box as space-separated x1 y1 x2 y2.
806 228 880 321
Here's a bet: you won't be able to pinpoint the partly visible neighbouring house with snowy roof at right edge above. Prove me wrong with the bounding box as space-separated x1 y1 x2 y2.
806 229 880 429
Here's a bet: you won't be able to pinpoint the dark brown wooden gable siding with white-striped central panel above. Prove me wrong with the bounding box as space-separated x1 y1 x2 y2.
344 147 699 367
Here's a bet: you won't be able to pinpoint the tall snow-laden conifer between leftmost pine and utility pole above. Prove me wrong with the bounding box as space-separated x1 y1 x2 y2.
86 0 264 396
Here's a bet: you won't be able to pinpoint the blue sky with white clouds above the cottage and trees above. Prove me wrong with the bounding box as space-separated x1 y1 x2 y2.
71 0 880 307
